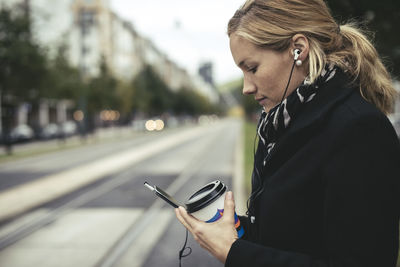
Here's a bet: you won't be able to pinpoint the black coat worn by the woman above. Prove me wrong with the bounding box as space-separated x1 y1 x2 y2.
225 72 400 267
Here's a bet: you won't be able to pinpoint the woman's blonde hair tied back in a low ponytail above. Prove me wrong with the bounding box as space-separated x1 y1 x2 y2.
228 0 396 114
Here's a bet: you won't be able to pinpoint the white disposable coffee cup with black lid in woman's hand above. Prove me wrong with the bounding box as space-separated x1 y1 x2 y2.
185 180 244 238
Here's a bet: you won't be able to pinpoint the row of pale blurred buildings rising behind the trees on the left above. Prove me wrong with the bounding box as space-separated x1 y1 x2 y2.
0 0 219 135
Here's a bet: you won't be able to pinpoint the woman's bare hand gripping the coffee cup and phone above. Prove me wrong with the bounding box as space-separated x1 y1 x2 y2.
175 192 238 263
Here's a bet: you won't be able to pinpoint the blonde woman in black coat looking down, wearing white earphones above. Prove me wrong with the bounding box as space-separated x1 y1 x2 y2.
176 0 400 267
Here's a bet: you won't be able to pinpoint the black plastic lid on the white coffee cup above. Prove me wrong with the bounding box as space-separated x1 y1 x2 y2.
185 180 226 213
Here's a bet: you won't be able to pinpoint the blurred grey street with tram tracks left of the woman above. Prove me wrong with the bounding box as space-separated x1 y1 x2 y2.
0 119 241 267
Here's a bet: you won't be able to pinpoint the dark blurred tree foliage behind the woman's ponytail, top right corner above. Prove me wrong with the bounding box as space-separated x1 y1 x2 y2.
327 0 400 79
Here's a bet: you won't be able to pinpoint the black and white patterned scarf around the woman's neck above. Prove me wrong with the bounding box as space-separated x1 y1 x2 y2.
257 64 337 165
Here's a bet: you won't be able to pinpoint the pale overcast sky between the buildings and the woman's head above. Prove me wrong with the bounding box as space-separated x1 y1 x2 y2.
110 0 244 83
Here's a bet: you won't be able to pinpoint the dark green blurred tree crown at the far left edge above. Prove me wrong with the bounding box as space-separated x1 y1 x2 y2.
0 9 47 101
